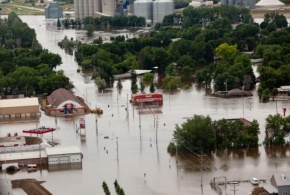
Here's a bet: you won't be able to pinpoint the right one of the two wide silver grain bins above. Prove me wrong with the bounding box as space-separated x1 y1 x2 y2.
153 0 174 22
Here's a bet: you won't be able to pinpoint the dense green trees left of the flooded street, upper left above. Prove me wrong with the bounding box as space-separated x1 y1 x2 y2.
0 13 73 95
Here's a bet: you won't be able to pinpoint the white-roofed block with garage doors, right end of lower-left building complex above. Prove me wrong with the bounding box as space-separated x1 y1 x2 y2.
46 146 82 165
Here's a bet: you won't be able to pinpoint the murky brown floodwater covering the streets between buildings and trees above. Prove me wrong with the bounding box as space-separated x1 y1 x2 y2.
0 16 290 195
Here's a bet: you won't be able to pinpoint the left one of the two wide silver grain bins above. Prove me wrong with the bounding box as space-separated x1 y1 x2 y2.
134 0 153 20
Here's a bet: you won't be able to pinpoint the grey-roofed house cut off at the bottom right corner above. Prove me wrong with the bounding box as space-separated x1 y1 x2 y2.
270 173 290 195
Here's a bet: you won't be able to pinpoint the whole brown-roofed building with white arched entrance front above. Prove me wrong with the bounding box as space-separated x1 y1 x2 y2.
47 88 88 116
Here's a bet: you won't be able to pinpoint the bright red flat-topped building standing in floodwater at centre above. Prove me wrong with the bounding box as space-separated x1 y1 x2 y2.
131 93 163 106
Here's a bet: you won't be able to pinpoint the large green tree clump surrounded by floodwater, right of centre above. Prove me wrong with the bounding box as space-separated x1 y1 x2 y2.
167 115 260 154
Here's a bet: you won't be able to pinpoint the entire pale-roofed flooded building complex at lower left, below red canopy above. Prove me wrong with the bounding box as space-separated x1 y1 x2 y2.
0 136 82 168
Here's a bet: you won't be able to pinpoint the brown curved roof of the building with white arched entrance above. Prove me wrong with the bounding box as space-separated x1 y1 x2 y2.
47 88 81 107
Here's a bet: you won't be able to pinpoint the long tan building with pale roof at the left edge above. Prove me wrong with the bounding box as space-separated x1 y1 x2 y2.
0 97 40 119
